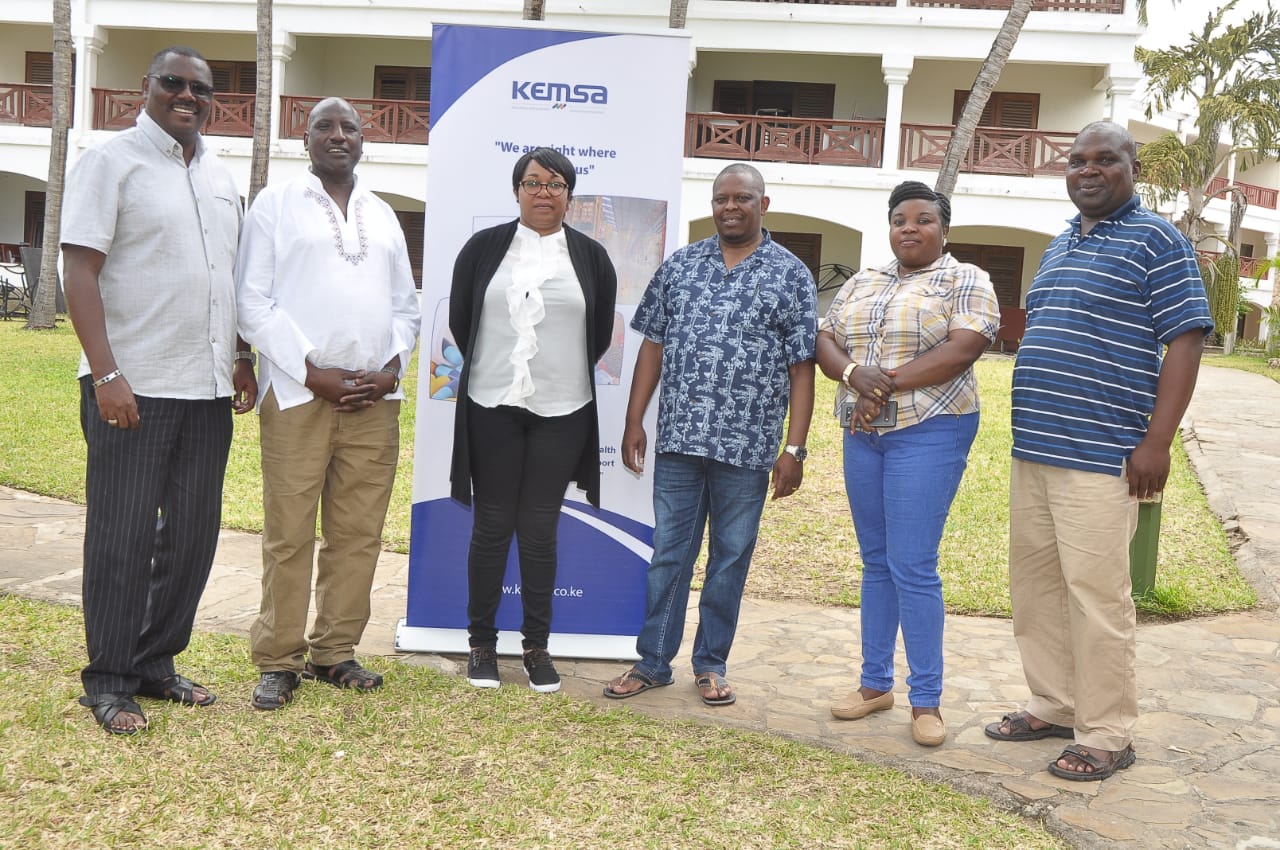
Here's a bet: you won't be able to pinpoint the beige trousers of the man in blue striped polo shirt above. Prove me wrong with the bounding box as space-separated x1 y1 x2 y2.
1009 458 1138 750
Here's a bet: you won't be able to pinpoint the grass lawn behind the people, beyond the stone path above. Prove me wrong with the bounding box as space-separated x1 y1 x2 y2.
0 323 1274 616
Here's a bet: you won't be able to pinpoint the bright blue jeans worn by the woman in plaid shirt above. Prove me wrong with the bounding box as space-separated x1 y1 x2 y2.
845 413 978 708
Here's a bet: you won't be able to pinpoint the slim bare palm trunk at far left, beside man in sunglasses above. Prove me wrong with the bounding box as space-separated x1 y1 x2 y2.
27 0 72 330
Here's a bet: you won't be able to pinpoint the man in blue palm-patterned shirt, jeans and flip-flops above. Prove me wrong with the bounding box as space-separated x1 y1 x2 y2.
604 163 818 705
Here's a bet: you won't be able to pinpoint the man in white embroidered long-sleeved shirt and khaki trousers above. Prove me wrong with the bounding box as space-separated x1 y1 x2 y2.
236 97 419 710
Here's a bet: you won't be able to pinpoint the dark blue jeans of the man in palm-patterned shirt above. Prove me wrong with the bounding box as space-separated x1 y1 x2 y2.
636 453 769 682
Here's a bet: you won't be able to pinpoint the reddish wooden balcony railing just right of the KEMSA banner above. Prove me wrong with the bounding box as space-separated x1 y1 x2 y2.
685 113 884 168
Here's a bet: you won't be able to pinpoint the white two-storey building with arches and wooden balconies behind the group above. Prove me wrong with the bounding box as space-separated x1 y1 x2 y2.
0 0 1280 341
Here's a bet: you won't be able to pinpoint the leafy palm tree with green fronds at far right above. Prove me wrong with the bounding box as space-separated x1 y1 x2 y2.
1134 0 1280 345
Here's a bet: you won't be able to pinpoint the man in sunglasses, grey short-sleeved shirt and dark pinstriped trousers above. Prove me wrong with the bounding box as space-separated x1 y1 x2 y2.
61 47 257 735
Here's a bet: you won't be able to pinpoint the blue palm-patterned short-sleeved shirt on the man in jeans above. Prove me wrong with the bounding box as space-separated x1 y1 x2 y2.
631 232 818 471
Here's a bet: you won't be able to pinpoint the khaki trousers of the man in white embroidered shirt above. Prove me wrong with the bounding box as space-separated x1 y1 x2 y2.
250 390 401 672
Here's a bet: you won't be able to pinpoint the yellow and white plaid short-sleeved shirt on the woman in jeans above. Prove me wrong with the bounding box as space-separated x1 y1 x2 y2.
818 253 1000 430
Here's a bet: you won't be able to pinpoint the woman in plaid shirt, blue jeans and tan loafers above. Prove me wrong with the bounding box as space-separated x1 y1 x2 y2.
818 180 1000 746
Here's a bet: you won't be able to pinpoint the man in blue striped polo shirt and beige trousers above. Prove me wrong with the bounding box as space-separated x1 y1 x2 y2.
986 122 1213 781
